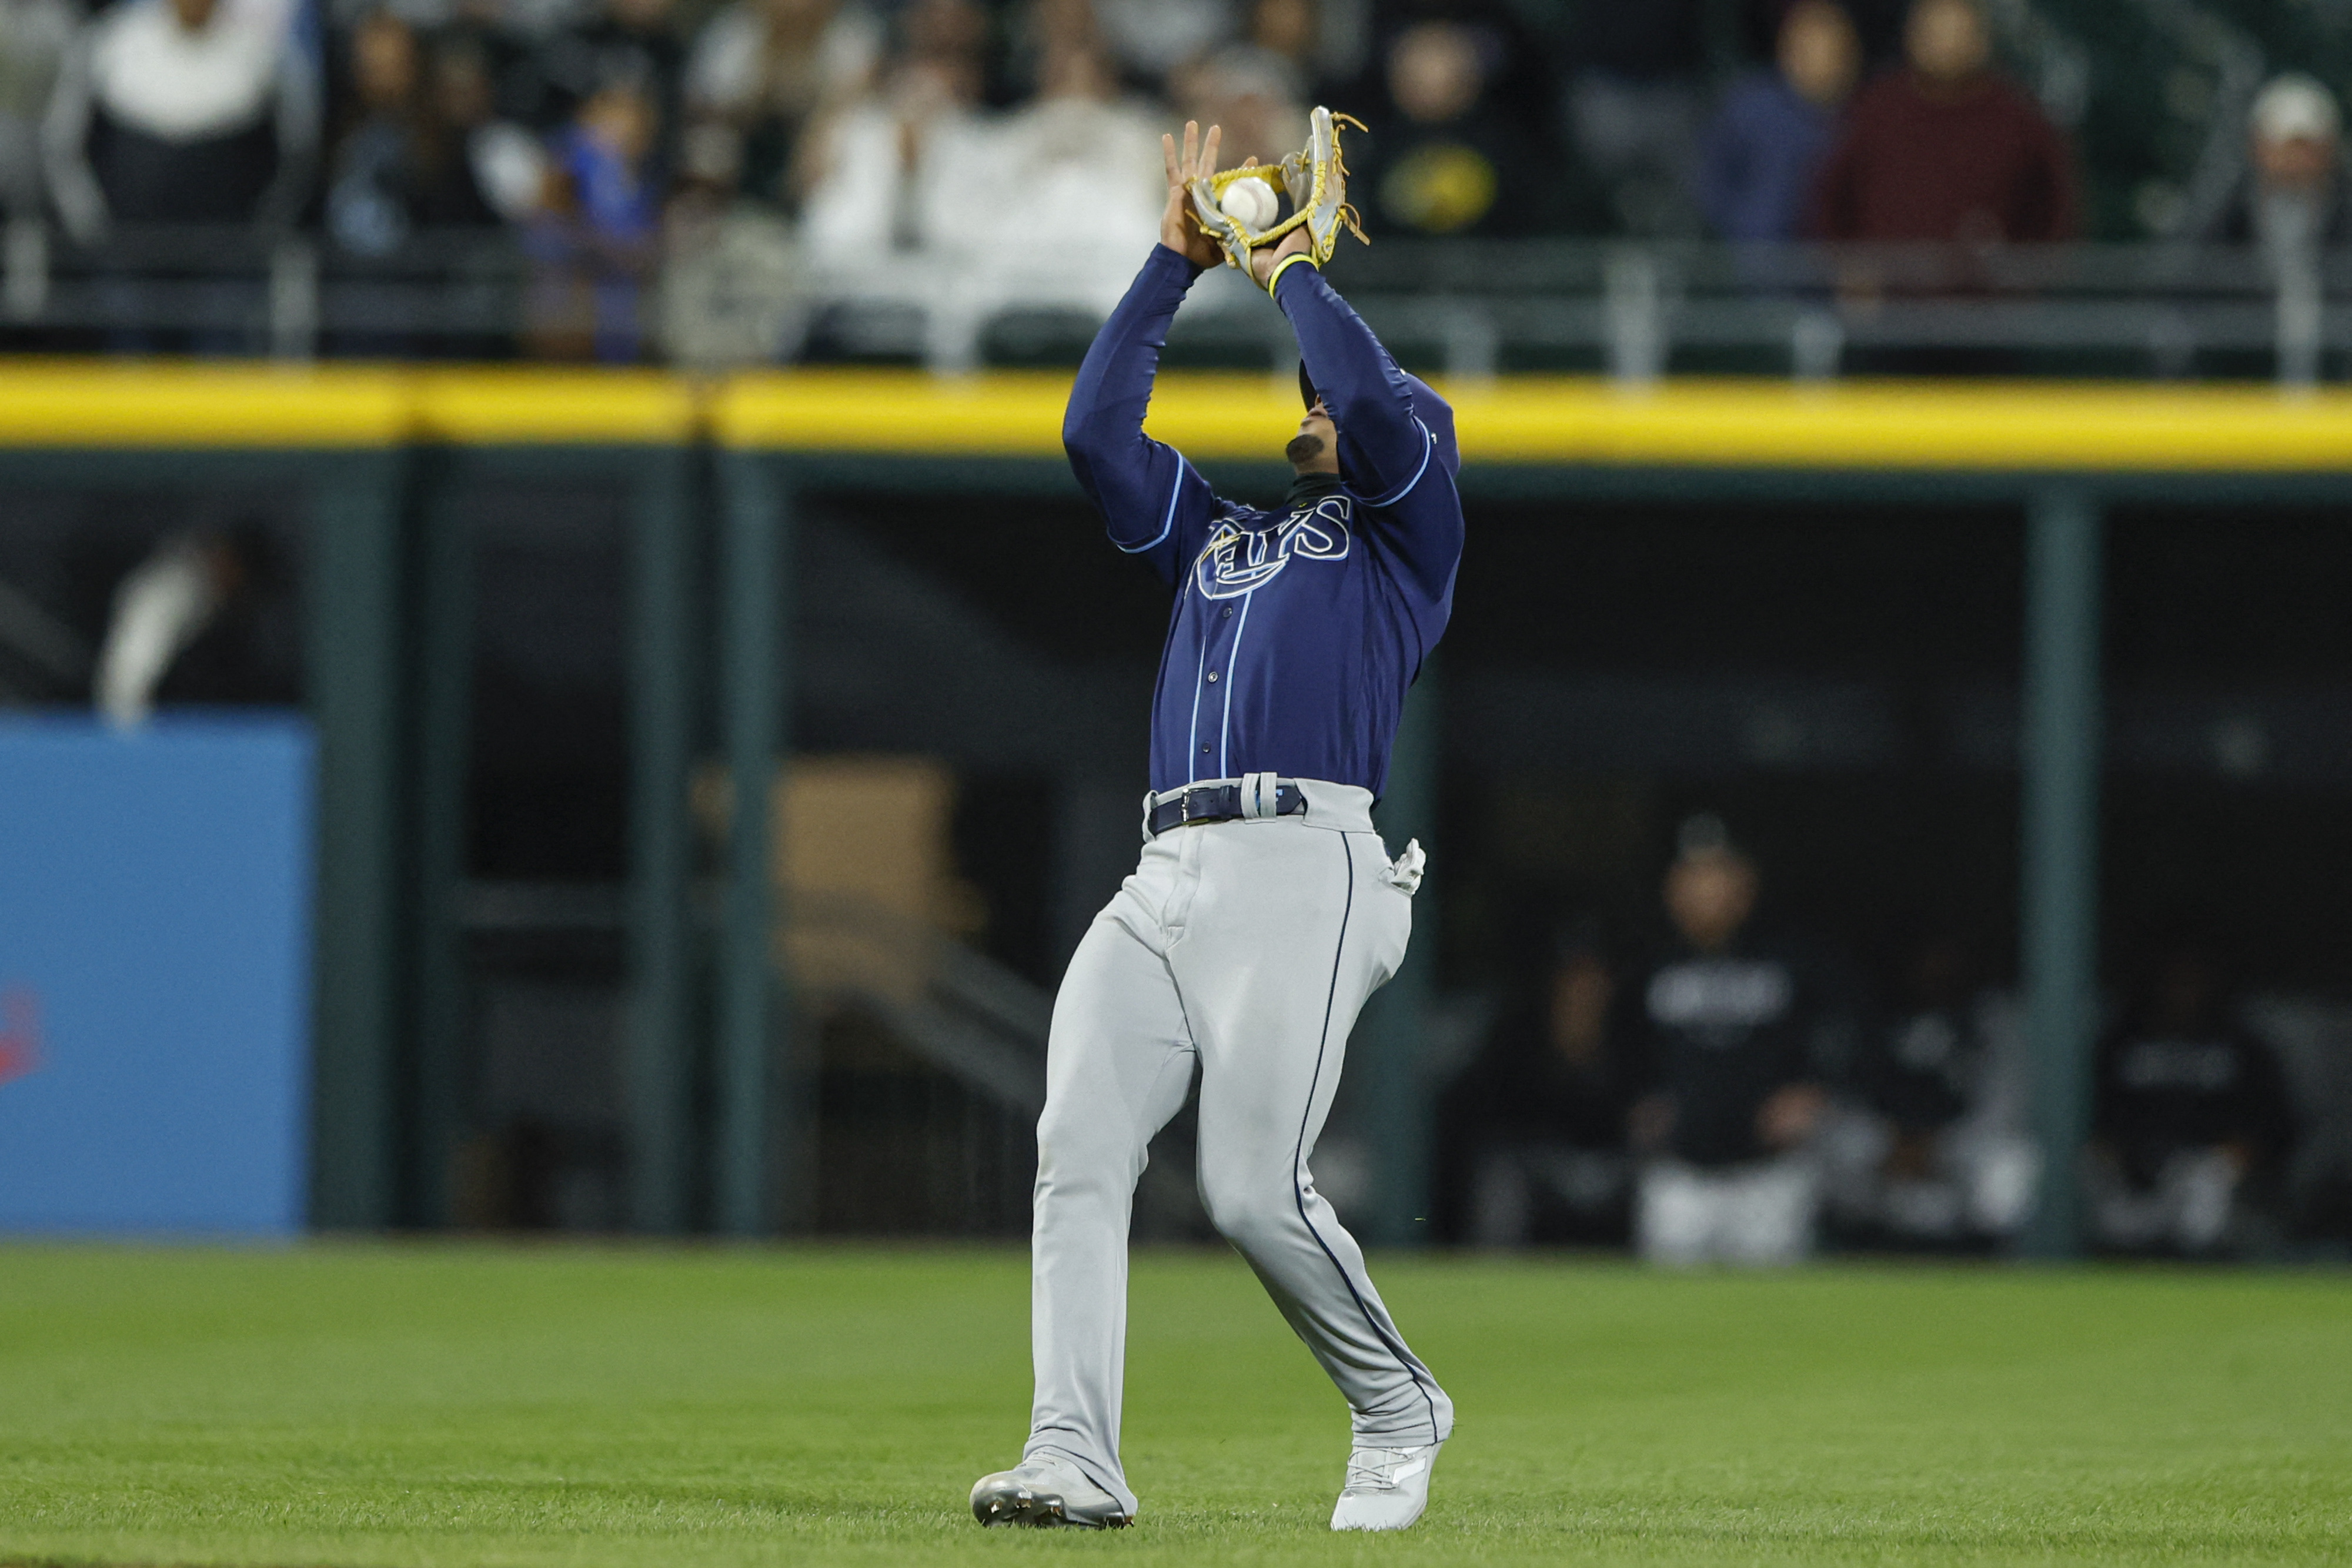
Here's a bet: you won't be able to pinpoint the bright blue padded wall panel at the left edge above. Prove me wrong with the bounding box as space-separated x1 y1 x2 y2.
0 715 313 1234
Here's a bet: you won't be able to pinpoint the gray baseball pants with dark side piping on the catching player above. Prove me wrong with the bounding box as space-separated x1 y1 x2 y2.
1023 781 1454 1512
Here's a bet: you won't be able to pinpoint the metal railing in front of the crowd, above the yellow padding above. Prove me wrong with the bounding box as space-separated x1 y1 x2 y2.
0 221 2352 386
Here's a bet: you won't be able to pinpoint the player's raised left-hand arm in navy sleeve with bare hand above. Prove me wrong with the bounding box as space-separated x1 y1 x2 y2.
1061 122 1218 576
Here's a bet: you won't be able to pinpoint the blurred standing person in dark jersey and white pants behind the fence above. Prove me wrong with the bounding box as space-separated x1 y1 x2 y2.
1632 815 1828 1262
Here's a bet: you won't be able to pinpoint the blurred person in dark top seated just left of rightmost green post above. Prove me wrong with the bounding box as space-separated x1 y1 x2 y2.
1858 935 2042 1241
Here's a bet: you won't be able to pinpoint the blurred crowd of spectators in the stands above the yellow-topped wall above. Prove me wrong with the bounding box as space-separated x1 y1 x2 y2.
0 0 2352 379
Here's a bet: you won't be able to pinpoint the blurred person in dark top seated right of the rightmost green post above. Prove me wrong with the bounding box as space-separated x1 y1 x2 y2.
2089 940 2293 1255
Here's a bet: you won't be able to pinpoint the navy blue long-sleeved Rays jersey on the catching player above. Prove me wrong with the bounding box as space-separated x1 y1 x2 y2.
1061 245 1463 794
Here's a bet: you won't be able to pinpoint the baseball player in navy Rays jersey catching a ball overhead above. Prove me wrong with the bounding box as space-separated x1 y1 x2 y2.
971 115 1463 1530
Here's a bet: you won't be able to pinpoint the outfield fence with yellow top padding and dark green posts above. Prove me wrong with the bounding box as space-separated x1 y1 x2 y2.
0 362 2352 1253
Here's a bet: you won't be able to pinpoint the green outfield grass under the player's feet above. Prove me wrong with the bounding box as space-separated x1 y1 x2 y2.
0 1243 2352 1568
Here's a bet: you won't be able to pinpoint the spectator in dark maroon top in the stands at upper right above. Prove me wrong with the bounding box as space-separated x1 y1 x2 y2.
1813 0 2074 247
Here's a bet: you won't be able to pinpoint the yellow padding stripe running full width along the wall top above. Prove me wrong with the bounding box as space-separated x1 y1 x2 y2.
14 360 2352 473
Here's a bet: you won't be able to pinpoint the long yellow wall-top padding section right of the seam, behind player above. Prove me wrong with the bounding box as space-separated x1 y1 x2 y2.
713 372 2352 473
